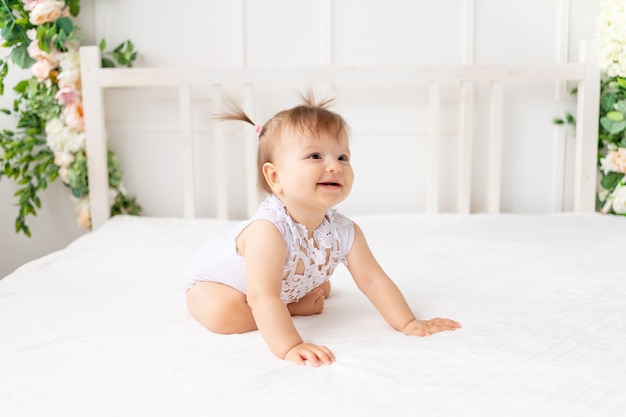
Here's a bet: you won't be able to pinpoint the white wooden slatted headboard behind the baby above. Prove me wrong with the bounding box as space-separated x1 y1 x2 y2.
80 42 600 229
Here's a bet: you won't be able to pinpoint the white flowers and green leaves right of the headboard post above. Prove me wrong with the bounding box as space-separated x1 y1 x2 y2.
597 0 626 215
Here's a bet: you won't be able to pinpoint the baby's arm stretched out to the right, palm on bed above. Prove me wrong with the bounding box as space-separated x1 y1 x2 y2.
347 224 461 336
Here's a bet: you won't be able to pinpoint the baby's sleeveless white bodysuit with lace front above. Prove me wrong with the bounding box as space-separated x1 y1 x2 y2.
185 195 354 303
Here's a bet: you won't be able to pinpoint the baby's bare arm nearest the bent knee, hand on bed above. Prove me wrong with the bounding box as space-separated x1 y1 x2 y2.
237 220 334 366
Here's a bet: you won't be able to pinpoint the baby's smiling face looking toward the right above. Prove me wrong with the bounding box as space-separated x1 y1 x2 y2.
274 131 354 211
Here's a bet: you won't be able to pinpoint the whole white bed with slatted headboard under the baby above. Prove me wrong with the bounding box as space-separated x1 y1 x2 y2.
0 43 626 417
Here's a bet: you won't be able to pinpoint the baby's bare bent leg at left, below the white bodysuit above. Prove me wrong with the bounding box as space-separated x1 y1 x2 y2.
187 282 257 334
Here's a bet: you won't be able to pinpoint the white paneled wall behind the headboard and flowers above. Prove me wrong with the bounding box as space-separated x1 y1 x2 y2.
0 0 598 276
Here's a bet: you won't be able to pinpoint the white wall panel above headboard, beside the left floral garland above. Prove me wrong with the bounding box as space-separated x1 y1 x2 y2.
97 0 236 66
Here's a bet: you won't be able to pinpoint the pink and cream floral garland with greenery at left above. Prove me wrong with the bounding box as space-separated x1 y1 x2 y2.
0 0 141 236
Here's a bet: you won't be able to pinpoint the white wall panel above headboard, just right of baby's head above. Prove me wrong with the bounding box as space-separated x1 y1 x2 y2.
334 0 463 65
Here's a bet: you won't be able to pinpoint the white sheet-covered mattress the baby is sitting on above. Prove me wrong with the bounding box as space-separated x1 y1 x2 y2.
0 214 626 417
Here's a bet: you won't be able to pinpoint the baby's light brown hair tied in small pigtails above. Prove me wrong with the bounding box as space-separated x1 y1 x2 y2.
215 89 348 193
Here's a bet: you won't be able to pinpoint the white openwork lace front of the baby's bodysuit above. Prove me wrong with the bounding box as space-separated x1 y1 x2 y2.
264 196 347 303
